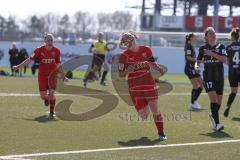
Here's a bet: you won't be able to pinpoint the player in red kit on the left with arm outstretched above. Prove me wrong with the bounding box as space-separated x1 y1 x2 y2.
14 34 63 119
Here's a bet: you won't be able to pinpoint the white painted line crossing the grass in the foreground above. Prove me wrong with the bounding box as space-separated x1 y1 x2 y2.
0 139 240 160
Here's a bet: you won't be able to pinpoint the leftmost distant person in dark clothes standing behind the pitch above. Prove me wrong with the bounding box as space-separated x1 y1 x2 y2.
8 42 18 76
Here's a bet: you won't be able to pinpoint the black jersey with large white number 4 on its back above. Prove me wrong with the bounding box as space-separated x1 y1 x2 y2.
226 42 240 70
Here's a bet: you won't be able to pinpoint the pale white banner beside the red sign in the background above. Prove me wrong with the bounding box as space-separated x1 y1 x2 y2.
155 15 184 29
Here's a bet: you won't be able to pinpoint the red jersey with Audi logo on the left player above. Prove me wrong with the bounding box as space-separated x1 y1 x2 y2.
31 46 61 76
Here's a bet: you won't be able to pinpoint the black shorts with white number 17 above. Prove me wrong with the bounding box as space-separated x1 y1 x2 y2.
203 80 224 95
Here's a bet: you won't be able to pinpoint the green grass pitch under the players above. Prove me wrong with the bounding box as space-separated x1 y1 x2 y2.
0 74 240 160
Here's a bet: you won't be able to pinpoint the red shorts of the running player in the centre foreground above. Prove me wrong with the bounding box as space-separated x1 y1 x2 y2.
129 85 158 111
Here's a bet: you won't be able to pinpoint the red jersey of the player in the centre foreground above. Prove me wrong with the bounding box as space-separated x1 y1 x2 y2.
119 46 155 88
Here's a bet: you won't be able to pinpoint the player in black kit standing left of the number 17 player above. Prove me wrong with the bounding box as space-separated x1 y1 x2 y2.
184 33 203 110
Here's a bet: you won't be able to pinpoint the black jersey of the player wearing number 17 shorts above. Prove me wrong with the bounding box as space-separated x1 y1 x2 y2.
197 43 227 81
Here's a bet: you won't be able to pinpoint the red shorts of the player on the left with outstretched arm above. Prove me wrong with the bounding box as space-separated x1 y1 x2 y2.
38 75 57 91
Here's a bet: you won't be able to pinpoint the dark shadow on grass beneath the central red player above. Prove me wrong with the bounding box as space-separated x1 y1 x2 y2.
118 137 161 146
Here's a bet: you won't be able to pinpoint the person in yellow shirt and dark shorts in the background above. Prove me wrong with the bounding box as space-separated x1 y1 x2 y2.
83 32 109 87
